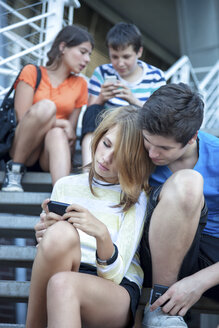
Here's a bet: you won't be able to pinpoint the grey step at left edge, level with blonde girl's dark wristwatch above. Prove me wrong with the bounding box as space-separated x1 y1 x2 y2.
0 245 37 268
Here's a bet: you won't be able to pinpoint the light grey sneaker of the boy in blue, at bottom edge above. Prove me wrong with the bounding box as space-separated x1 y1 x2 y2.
142 305 188 328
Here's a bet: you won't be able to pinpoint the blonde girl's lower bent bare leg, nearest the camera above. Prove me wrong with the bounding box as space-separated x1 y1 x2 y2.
47 272 130 328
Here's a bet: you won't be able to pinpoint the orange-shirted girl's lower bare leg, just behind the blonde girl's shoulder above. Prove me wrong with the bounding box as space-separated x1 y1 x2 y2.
40 127 72 185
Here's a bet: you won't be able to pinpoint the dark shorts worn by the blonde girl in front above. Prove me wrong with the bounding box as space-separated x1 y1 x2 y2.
79 263 140 328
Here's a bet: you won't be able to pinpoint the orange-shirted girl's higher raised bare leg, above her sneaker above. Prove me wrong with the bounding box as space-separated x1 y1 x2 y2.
10 99 56 166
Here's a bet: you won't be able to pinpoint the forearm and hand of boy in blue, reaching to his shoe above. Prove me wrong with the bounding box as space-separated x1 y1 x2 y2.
151 262 219 316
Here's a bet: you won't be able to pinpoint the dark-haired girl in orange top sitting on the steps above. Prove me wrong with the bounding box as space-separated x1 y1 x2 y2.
2 25 93 191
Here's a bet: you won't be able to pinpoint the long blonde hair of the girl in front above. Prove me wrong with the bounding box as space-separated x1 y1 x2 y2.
89 105 154 211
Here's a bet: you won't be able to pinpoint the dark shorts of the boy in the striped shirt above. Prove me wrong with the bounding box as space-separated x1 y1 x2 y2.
81 105 103 141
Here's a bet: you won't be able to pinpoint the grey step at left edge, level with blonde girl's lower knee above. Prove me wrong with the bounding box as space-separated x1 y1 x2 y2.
0 280 30 302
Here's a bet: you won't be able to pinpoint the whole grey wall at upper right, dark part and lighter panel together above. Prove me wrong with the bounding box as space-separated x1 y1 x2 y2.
80 0 219 67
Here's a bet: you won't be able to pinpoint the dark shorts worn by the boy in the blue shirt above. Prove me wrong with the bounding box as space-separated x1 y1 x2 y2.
140 186 219 300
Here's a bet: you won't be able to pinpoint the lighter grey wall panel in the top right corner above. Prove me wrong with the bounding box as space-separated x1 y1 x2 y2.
177 0 219 67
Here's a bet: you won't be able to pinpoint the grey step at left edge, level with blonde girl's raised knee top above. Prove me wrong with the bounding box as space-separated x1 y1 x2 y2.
0 213 39 238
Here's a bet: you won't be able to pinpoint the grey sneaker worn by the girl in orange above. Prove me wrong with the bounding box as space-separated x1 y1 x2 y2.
2 161 26 192
